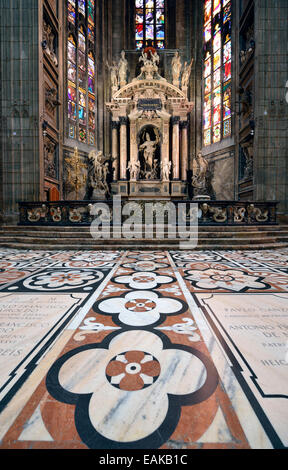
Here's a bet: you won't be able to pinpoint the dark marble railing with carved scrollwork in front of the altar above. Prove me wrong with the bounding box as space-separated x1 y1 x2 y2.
19 200 278 226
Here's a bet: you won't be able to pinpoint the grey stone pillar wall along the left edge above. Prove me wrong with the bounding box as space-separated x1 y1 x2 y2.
0 0 40 221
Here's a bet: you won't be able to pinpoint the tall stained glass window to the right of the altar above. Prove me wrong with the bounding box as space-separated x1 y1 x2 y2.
203 0 232 146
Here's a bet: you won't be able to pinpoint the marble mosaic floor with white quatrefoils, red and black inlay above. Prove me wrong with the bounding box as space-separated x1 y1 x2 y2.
0 249 288 449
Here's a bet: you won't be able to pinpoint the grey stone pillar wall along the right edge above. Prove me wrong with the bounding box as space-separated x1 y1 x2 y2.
254 0 288 214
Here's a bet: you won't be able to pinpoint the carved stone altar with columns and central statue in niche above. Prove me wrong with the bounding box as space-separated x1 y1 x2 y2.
106 50 193 199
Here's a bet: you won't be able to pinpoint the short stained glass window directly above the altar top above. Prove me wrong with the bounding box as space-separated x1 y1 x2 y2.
135 0 165 50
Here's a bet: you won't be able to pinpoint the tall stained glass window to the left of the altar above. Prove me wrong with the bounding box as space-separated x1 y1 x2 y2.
67 0 96 145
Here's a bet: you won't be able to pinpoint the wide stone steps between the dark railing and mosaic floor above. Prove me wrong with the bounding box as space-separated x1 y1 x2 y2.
0 225 288 250
